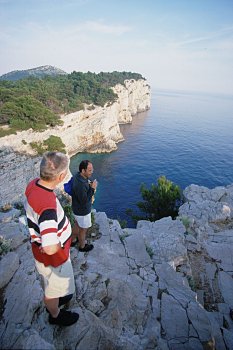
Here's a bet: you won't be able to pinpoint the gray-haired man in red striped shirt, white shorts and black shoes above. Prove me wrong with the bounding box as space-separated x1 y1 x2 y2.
25 152 79 326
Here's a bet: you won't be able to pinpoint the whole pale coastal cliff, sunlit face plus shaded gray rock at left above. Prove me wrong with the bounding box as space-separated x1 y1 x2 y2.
0 79 150 206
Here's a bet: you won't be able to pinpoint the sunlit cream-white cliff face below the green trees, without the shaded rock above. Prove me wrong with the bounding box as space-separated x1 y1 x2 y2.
0 79 150 155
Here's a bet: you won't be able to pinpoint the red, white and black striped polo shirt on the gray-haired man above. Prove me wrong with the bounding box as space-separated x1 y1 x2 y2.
25 179 71 267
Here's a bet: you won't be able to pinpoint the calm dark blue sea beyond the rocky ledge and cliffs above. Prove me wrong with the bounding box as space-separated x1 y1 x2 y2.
70 91 233 227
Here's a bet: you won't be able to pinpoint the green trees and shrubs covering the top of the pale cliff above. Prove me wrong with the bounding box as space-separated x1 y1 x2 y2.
0 72 143 137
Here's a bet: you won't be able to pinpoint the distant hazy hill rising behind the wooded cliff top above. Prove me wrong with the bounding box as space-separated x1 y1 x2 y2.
0 66 67 80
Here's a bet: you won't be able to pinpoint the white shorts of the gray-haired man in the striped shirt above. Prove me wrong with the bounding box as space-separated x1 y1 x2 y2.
35 258 75 298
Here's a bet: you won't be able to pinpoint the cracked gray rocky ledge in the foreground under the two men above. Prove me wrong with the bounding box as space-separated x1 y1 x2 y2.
0 185 233 350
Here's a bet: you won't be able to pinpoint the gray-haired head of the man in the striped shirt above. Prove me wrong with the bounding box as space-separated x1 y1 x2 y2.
40 152 69 182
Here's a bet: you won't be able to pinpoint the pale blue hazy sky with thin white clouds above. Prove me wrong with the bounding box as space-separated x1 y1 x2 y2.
0 0 233 94
